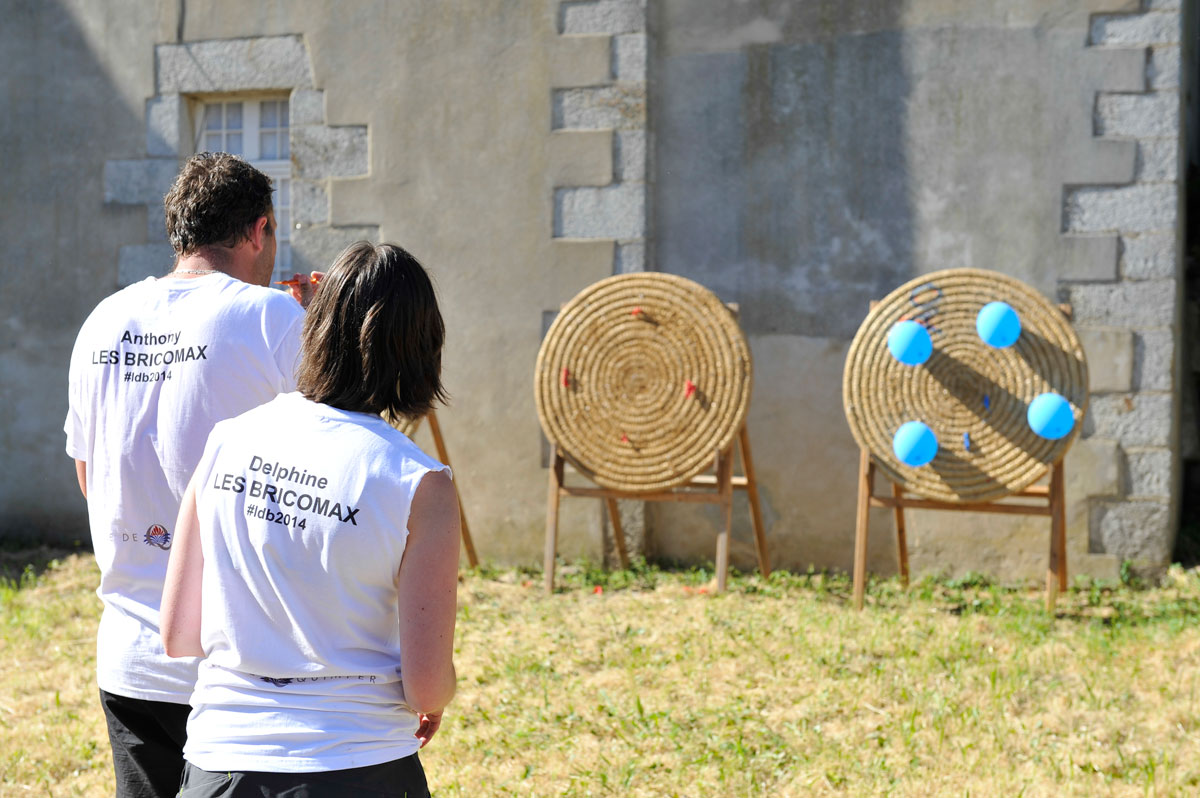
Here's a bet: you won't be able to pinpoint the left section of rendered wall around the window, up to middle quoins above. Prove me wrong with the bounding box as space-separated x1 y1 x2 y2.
0 0 614 562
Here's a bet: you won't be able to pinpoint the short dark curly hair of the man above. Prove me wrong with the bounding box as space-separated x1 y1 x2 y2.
163 152 271 256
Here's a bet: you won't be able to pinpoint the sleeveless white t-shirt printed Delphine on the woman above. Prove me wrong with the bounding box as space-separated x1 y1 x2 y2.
184 394 445 773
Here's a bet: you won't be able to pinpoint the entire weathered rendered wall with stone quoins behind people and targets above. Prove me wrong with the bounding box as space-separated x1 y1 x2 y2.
0 0 1183 578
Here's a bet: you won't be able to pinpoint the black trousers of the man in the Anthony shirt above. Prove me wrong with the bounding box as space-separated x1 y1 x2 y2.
100 690 192 798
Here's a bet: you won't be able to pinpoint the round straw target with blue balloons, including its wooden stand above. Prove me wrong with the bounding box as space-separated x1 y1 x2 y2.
842 269 1088 612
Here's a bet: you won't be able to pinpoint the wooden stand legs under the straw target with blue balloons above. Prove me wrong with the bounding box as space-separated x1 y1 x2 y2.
854 449 1067 612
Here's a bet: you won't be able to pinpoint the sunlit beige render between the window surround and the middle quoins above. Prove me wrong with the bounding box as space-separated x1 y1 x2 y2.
172 0 612 562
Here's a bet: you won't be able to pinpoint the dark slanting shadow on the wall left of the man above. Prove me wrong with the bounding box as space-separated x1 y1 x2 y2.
0 1 149 545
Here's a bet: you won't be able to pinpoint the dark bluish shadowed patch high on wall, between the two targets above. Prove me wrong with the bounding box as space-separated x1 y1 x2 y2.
650 1 913 338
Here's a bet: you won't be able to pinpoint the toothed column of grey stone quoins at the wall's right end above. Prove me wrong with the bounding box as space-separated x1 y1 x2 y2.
1060 0 1182 572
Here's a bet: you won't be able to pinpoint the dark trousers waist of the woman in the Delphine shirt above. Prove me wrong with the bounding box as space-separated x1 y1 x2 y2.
179 754 430 798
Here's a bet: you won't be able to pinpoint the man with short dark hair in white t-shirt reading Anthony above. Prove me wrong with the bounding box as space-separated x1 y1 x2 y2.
65 152 311 798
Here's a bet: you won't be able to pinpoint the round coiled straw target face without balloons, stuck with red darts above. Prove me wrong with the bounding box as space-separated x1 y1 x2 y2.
534 272 751 492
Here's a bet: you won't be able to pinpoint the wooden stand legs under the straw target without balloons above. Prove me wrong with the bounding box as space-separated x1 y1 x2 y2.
545 421 770 594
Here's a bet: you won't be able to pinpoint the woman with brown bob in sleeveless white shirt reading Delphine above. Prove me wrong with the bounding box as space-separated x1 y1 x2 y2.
162 242 460 798
